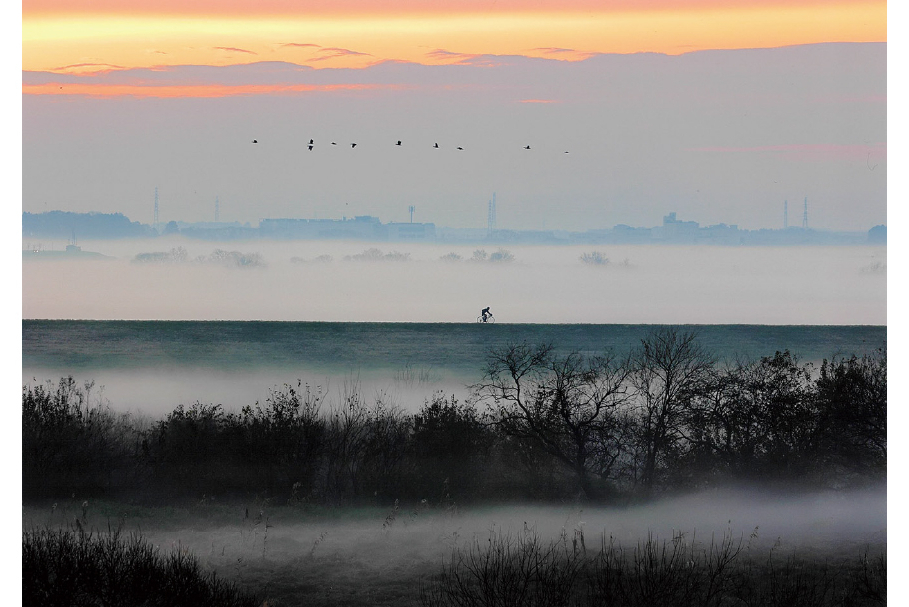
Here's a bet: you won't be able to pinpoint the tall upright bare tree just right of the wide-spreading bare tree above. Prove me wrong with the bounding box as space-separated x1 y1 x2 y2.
632 326 715 494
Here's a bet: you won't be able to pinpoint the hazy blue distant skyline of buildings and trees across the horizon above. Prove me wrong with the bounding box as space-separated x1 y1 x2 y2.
22 210 887 252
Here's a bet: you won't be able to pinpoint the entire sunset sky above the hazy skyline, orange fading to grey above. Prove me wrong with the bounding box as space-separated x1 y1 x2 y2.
22 0 887 231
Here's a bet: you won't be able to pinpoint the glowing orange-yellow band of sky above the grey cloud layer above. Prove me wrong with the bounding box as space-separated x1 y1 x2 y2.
22 0 887 78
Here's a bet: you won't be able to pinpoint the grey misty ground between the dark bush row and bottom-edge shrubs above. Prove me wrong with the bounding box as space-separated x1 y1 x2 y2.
23 488 887 605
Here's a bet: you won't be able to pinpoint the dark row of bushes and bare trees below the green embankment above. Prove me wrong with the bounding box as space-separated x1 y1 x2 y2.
22 327 887 505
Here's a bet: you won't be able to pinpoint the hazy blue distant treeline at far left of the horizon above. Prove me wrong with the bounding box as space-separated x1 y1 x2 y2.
22 211 157 239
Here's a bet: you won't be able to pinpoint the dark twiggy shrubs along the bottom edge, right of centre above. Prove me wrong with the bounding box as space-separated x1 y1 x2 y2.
420 530 887 607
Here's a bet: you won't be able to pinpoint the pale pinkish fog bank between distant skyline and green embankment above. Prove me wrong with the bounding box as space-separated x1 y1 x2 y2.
22 238 886 325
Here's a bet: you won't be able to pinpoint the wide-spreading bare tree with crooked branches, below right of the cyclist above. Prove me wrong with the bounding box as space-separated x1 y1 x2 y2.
473 343 629 496
